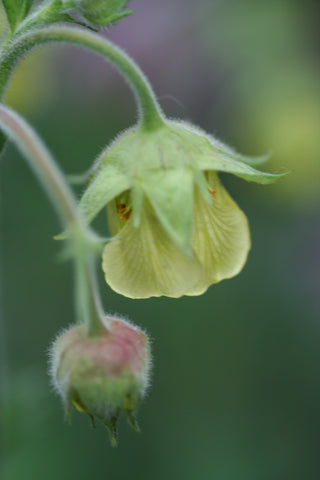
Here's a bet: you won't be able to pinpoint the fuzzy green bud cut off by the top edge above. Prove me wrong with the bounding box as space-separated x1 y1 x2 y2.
75 0 132 27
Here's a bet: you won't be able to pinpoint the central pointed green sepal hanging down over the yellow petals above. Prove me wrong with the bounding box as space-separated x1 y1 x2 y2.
139 168 193 255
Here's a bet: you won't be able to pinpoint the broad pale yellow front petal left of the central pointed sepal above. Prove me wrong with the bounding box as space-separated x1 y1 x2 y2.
102 205 203 298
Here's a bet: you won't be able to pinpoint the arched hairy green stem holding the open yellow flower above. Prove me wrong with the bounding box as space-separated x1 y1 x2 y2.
0 26 164 130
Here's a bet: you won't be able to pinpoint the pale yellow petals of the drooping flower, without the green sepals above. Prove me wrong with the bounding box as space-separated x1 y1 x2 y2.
102 172 250 298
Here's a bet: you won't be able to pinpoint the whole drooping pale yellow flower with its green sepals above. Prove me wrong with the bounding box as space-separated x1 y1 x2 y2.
80 122 285 298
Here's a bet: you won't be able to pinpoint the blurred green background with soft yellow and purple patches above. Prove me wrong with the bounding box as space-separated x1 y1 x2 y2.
0 0 320 480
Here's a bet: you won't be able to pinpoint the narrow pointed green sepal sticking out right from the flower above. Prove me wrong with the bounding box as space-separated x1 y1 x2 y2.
198 149 290 184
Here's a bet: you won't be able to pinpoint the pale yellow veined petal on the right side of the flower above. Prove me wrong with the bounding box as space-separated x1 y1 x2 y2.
186 172 250 295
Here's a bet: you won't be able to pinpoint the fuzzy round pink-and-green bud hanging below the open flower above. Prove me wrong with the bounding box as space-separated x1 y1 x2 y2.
50 317 150 445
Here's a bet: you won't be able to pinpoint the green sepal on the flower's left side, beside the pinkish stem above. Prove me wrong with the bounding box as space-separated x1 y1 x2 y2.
79 164 131 223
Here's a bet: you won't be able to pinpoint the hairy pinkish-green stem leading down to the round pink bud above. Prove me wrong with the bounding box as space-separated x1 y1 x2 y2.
0 105 108 335
